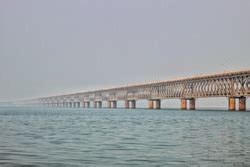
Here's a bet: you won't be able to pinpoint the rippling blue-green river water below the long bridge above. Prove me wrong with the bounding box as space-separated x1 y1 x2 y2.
0 108 250 166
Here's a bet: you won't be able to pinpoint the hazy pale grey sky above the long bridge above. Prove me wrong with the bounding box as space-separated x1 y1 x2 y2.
0 0 250 101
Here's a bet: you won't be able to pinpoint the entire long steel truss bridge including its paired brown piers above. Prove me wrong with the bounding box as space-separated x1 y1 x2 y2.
18 70 250 111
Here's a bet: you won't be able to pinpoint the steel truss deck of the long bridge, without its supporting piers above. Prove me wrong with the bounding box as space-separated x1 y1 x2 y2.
18 70 250 111
